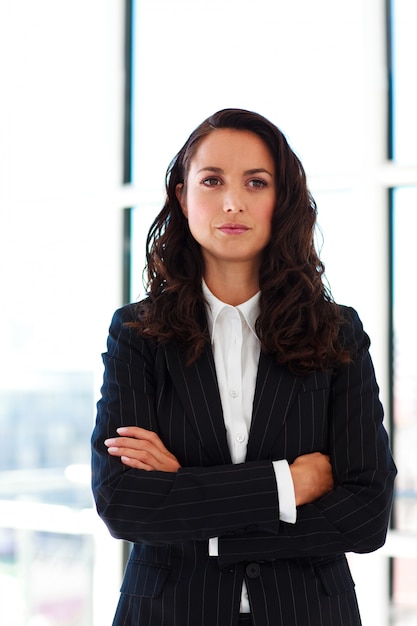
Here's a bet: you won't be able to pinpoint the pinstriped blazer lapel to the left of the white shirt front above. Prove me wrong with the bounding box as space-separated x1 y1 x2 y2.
166 344 232 465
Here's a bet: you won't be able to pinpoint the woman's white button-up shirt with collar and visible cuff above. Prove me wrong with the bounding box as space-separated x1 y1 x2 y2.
203 281 296 613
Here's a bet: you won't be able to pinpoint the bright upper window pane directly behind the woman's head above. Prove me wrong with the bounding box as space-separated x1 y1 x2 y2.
133 0 365 192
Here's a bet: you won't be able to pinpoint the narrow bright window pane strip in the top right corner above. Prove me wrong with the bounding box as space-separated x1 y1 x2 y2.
392 0 417 163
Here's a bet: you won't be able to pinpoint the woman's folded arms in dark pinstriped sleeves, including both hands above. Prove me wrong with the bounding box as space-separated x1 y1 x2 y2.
92 309 395 562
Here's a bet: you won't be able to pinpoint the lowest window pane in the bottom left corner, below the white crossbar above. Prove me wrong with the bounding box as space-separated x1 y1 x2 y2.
0 529 93 626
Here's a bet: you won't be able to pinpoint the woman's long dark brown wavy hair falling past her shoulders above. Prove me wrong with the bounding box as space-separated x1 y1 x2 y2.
131 109 350 374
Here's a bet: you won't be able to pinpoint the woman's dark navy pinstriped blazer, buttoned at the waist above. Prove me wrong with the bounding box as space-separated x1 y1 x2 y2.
92 305 396 626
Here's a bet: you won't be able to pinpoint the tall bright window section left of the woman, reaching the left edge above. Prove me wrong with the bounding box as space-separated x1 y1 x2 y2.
0 0 123 626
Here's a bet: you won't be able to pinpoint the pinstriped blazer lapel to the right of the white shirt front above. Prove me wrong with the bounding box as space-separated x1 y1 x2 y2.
246 352 303 461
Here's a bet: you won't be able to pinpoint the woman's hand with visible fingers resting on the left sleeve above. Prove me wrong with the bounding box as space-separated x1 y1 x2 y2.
104 426 181 472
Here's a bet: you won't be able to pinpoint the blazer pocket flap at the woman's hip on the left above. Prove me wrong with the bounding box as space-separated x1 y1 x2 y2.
120 559 171 598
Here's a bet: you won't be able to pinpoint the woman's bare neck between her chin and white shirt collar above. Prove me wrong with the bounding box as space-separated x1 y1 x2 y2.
204 265 259 306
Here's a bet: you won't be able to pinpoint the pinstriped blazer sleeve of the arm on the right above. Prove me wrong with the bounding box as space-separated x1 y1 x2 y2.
219 309 396 565
